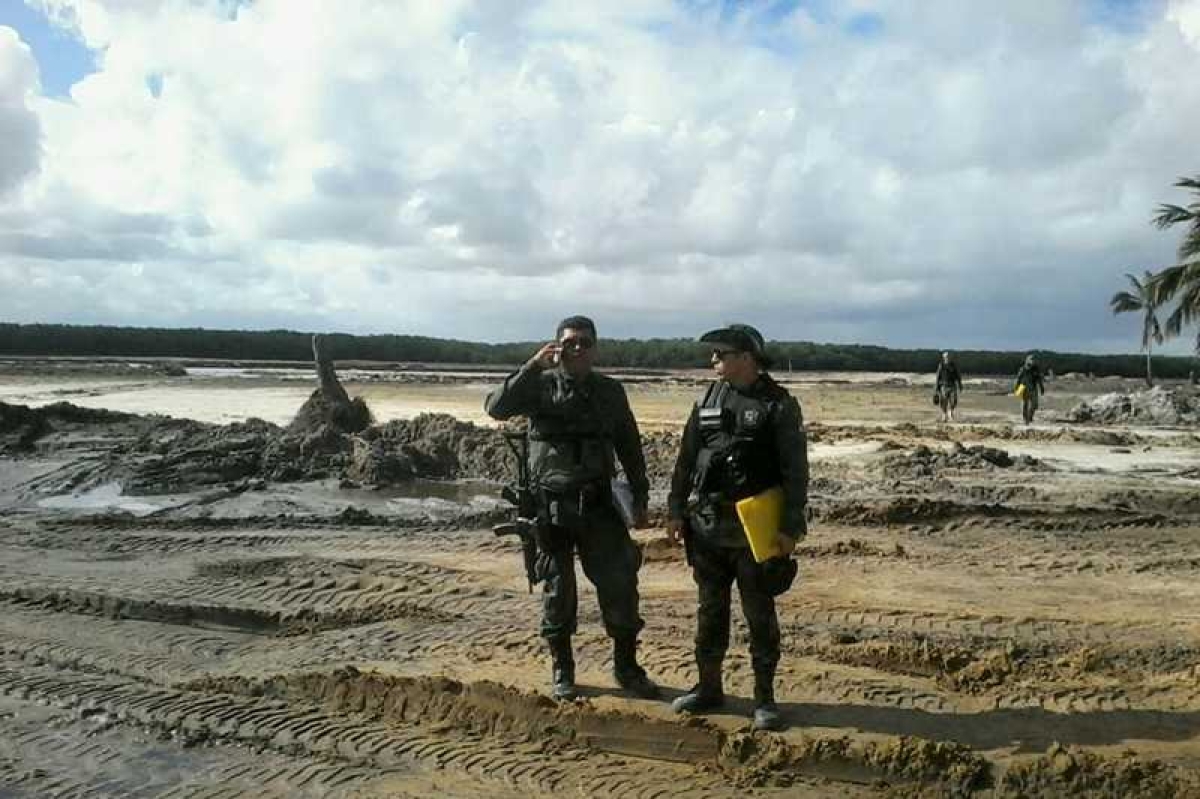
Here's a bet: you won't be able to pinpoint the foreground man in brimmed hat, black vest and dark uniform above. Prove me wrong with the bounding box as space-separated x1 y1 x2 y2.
667 325 809 729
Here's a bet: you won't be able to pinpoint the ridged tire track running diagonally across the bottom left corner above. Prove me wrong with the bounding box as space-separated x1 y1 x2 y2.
0 665 753 798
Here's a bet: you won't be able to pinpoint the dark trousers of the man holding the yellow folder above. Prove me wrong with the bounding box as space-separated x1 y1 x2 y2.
691 536 780 675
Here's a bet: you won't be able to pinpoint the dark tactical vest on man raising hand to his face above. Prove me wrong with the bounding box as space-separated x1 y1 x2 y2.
529 378 616 491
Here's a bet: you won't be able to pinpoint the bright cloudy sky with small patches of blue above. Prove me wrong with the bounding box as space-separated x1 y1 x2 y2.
0 0 1200 353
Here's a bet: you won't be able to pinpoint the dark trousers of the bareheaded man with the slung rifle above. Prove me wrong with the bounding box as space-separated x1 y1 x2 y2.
541 505 646 639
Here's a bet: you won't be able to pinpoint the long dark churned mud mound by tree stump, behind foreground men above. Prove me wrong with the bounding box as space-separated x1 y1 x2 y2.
0 394 696 495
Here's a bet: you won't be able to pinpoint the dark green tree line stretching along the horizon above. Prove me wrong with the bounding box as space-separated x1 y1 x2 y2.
0 324 1194 378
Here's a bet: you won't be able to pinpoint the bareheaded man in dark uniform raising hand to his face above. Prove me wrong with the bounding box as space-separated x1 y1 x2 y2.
485 317 659 699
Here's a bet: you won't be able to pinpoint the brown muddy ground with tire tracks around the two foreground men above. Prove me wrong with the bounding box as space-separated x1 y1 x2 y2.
0 364 1200 798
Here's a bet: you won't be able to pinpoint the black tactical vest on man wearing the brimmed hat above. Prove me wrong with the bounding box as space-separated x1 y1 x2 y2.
692 376 782 506
